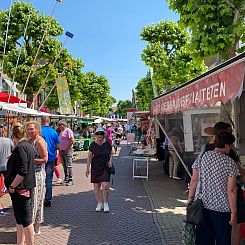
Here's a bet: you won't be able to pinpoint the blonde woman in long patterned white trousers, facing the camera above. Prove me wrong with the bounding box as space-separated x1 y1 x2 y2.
26 121 48 235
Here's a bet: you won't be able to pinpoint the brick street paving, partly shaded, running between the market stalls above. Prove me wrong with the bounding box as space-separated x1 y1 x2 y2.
0 141 186 245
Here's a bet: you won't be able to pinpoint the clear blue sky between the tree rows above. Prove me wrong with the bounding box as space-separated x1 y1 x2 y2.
0 0 178 100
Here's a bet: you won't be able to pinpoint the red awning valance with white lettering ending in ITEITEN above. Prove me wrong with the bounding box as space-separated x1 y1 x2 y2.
151 62 245 116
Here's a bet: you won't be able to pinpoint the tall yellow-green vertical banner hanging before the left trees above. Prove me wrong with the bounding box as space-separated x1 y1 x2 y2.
55 77 72 115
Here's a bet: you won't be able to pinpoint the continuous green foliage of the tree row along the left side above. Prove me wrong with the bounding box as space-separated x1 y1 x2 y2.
0 1 115 116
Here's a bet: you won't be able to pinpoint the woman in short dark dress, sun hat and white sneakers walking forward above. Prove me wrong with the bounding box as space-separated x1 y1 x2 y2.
86 128 112 212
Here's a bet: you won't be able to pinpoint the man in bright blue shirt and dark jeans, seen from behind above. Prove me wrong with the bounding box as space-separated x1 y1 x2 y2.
41 116 60 207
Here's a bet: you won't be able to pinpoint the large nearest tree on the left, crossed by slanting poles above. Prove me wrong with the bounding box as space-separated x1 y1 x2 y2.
0 1 83 103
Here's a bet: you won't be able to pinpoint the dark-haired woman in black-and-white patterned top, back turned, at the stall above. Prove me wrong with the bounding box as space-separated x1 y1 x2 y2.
188 131 239 245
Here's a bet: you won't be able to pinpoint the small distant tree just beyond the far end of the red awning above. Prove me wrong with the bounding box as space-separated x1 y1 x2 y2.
135 73 154 111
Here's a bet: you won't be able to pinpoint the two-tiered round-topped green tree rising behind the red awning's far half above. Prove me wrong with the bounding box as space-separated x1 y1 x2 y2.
141 20 205 94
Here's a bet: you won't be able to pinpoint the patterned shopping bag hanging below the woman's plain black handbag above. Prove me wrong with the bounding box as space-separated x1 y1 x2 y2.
181 220 196 245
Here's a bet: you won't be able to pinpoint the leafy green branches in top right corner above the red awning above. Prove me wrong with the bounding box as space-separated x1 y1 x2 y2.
167 0 245 59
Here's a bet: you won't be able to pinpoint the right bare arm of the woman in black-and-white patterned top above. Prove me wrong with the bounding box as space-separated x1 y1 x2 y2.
227 176 237 224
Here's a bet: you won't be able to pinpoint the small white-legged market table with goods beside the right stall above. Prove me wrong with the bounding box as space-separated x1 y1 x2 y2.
129 148 156 180
